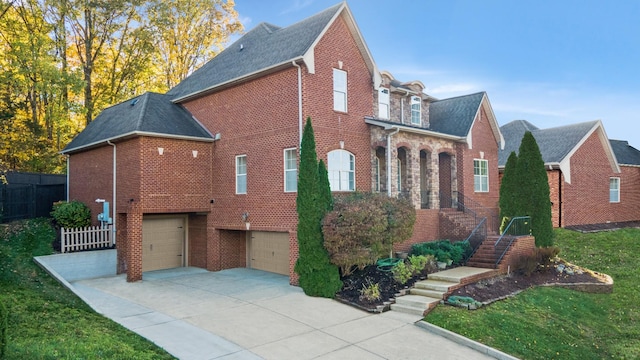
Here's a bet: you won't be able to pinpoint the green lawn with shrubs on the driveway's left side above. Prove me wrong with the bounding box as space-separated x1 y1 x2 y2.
0 219 173 359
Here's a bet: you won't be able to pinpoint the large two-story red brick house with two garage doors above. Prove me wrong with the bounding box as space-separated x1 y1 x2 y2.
63 3 504 284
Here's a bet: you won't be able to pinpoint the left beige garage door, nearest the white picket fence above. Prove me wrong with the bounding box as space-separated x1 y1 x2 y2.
142 217 185 271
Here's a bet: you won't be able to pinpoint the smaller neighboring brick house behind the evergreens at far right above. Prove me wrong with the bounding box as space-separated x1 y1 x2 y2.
499 120 640 227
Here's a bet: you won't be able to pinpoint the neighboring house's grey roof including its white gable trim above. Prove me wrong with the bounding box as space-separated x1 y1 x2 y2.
498 120 620 184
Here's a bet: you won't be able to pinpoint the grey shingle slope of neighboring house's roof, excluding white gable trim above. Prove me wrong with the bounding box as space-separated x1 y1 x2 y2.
498 120 598 166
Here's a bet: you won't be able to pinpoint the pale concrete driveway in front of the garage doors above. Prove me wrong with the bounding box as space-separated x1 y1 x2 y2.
70 268 501 360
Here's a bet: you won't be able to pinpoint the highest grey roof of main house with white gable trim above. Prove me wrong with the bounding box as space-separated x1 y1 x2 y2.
167 2 379 102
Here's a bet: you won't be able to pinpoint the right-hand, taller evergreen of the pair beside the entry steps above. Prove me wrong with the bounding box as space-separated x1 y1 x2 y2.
514 131 553 247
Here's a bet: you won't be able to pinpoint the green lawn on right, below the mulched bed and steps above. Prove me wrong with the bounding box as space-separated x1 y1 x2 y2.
426 229 640 360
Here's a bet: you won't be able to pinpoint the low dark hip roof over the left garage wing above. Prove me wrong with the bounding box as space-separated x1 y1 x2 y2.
62 92 213 154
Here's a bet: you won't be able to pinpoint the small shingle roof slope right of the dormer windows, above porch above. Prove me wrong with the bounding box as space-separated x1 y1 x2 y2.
428 91 485 136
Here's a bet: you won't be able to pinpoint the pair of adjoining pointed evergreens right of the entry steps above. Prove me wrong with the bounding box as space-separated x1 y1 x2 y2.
500 131 553 247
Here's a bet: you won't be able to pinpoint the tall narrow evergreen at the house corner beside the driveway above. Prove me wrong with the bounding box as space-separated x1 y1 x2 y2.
295 118 342 298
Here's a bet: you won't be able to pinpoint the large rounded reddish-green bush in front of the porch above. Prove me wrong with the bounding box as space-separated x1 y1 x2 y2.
322 192 416 276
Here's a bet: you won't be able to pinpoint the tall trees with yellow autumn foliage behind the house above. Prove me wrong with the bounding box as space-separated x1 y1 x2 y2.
0 0 242 173
